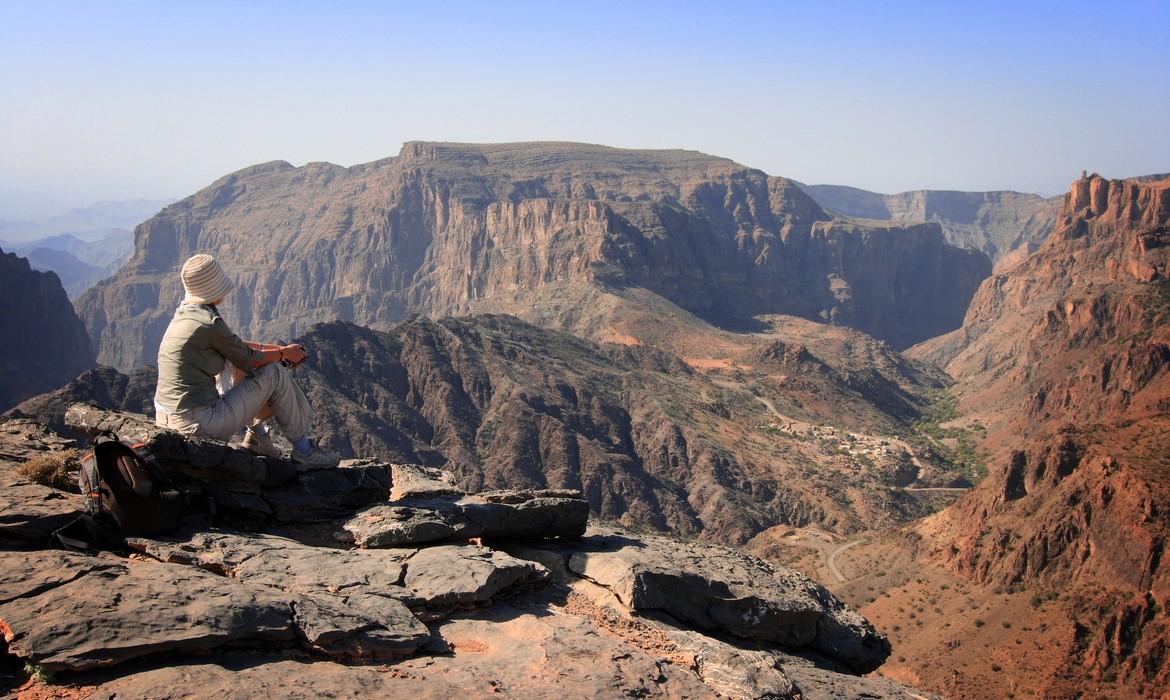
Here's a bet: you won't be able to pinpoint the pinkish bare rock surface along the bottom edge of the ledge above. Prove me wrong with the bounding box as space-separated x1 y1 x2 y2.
90 605 711 700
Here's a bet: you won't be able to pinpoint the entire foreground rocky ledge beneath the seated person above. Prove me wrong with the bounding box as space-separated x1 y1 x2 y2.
0 410 922 699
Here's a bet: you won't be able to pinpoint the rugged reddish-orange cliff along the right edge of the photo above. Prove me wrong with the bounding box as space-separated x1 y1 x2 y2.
911 176 1170 693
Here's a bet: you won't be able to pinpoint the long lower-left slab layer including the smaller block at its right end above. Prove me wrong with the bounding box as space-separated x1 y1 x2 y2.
0 551 431 671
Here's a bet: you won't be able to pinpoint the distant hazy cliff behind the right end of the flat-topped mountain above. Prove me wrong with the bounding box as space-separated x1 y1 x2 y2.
801 185 1062 265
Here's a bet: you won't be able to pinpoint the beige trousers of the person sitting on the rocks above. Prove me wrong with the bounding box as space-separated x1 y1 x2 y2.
154 362 312 442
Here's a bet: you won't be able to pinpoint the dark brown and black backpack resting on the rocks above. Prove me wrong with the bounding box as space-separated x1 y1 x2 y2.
77 433 188 537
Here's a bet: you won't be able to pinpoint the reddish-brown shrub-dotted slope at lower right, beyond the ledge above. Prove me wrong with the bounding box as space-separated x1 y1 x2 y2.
749 528 1156 700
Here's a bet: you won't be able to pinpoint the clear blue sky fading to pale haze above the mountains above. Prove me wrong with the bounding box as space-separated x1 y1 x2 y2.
0 0 1170 220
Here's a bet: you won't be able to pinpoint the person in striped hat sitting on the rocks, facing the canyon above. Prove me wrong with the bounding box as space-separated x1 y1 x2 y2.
154 254 338 466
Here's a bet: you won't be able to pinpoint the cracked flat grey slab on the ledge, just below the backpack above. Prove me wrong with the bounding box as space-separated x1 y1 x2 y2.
130 530 548 613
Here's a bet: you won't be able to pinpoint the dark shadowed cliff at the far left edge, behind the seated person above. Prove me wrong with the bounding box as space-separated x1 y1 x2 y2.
0 251 94 411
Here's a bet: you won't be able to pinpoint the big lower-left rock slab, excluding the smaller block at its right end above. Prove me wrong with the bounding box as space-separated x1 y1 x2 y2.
0 551 296 671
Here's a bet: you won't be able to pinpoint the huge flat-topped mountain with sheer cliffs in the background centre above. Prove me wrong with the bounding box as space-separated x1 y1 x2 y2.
78 143 990 370
